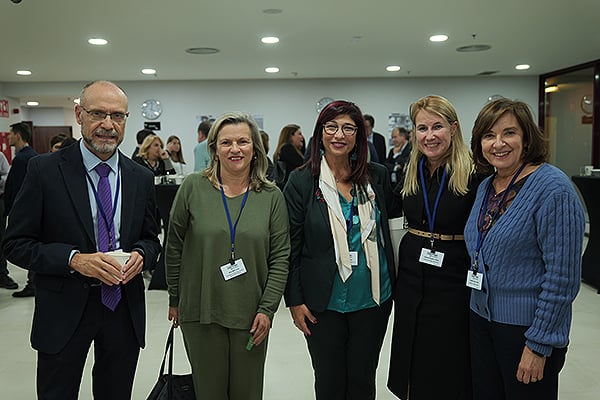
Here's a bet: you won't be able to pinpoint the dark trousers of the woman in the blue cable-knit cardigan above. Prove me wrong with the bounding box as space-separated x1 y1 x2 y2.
470 312 567 400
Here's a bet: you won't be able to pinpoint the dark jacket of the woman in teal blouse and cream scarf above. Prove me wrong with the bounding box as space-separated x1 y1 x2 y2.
284 164 399 312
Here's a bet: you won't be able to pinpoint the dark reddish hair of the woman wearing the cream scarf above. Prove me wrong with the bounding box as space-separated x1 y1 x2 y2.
308 100 369 185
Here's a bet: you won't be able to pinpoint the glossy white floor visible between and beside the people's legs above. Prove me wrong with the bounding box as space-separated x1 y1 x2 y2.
0 266 600 400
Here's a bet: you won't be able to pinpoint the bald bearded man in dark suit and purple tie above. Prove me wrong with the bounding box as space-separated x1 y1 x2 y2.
4 81 160 400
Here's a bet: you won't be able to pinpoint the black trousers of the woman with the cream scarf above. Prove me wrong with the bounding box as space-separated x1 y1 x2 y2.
306 299 392 400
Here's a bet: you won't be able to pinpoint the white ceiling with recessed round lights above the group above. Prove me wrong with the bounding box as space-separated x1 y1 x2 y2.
0 0 600 84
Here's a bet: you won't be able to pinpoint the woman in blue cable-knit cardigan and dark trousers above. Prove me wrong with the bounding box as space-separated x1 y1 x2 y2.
465 99 585 400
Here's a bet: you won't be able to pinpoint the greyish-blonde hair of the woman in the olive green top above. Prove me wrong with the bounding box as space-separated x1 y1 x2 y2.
205 112 275 192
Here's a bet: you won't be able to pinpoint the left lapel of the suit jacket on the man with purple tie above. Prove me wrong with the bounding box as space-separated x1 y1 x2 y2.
59 144 96 244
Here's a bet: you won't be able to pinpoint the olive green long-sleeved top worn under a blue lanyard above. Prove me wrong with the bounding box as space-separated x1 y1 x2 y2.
165 173 290 329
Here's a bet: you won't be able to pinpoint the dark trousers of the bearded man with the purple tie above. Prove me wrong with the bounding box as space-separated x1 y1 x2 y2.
37 286 140 400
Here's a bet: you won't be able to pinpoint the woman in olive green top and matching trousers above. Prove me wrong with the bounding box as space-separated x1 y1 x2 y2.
166 113 290 400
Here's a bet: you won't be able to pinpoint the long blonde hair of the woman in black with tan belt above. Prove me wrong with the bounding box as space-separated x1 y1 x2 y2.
402 95 473 197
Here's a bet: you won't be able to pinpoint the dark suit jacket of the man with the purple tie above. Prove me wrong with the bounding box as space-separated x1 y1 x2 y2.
4 145 160 354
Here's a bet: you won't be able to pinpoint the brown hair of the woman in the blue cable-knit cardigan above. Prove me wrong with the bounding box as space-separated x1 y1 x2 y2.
471 98 548 173
